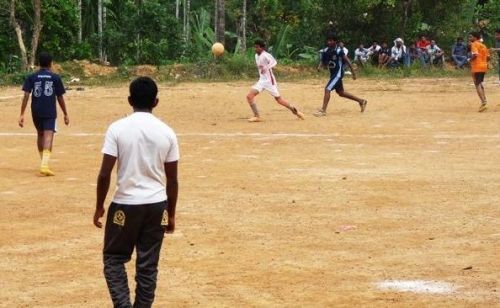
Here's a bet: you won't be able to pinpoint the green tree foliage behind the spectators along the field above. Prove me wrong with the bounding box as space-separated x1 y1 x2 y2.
0 0 500 69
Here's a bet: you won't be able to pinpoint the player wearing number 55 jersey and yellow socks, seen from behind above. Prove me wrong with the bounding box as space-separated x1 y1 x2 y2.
19 53 69 176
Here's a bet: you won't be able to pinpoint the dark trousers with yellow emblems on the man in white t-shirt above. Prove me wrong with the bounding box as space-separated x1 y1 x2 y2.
103 201 167 308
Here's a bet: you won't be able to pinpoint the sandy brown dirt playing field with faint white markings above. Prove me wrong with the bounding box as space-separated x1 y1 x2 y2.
0 77 500 307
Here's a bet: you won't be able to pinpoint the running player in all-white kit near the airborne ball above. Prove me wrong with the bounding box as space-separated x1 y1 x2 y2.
243 40 304 122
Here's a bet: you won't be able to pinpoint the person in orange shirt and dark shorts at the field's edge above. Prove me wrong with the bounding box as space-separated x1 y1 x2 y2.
469 32 490 112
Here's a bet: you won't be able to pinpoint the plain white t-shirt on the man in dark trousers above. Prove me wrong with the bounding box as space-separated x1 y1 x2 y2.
102 112 179 205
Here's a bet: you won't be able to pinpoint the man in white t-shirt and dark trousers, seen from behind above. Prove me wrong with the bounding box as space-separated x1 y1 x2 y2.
94 77 179 307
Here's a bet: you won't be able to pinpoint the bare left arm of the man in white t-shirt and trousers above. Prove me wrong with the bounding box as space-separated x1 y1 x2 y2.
94 154 116 228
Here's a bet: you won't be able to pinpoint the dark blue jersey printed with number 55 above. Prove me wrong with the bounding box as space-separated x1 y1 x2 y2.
23 69 66 118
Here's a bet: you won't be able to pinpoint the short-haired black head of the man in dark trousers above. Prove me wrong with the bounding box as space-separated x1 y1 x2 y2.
129 77 158 109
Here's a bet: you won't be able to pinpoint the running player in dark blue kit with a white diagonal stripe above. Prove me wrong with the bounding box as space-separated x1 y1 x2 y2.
314 35 368 117
